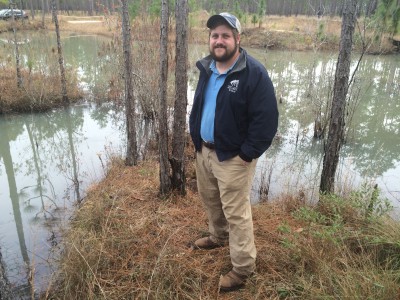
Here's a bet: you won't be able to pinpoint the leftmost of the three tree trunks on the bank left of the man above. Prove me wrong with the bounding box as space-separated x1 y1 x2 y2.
121 0 137 166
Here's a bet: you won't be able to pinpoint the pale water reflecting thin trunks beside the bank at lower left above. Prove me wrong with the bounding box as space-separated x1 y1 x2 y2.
0 105 124 295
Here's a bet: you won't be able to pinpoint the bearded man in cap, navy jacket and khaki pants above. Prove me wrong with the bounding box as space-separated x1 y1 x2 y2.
189 13 278 291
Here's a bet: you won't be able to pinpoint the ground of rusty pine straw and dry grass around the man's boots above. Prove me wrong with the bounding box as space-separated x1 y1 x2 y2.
46 161 400 299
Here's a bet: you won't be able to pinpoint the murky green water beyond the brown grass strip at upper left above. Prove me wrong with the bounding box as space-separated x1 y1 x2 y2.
0 31 119 101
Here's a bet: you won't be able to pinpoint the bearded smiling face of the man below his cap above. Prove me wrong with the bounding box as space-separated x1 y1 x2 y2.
210 25 240 62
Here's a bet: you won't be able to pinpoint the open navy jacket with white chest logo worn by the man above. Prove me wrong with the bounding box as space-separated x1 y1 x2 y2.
189 49 279 161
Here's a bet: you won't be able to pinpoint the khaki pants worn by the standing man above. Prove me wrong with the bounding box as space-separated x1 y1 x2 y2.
196 146 257 275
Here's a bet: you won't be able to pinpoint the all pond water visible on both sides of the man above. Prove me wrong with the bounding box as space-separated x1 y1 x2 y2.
0 35 400 295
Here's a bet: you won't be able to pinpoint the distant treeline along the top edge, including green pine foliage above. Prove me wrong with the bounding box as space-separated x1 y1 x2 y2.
0 0 400 40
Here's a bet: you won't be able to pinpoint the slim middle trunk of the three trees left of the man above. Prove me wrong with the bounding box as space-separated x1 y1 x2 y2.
158 0 171 195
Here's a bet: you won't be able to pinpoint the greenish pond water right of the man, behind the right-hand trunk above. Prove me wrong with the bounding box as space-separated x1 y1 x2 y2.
244 50 400 206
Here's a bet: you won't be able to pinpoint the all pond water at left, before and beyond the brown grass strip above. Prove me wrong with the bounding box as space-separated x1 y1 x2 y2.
0 32 125 297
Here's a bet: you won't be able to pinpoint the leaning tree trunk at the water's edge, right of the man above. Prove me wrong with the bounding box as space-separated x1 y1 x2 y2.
320 0 357 193
